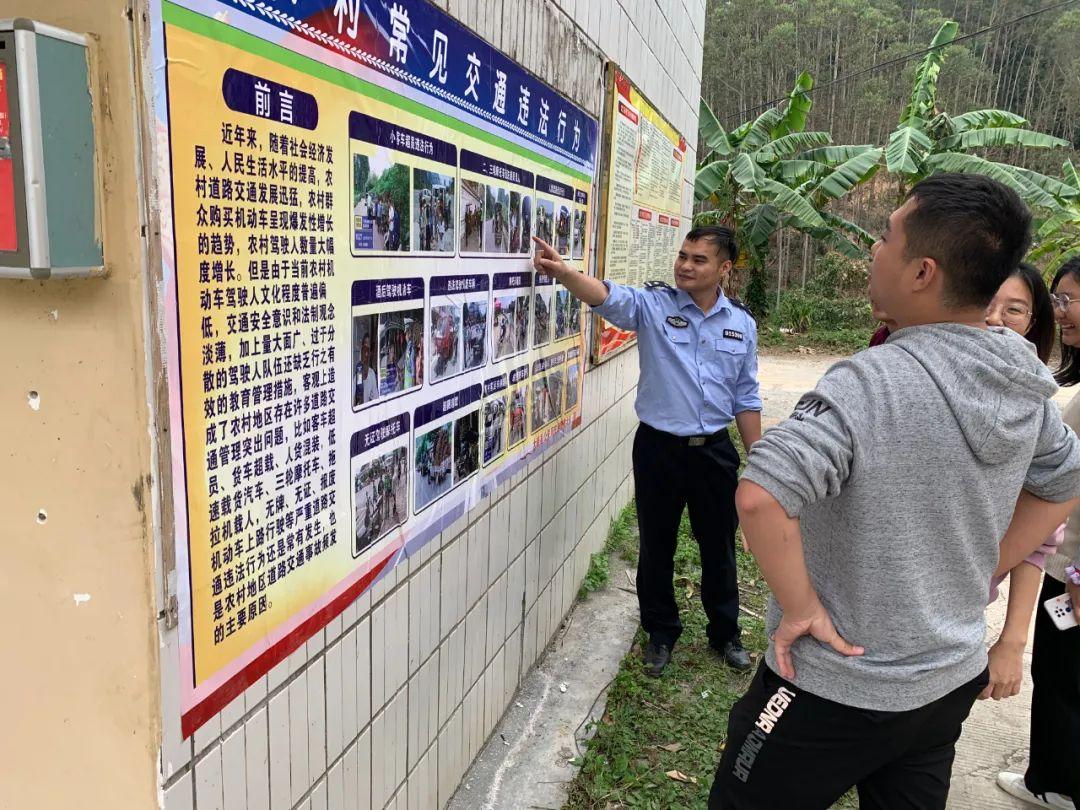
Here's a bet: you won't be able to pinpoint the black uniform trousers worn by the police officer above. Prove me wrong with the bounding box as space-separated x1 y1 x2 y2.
634 422 739 648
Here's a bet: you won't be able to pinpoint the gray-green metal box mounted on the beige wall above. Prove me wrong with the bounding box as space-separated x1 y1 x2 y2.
0 19 104 279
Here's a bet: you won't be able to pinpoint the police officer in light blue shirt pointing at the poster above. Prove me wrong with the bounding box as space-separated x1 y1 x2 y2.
534 226 761 676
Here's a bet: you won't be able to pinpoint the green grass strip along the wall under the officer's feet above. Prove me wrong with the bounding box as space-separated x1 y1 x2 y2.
564 427 858 810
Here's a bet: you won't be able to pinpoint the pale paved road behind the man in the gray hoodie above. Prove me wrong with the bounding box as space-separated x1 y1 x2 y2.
758 354 1062 810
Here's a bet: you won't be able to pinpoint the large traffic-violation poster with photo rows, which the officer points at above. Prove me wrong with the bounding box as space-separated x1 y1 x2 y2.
145 0 597 737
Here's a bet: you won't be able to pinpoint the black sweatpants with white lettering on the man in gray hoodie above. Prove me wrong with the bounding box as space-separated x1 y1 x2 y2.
708 658 989 810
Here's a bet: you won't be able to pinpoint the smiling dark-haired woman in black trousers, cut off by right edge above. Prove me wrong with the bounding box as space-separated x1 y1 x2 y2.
998 257 1080 808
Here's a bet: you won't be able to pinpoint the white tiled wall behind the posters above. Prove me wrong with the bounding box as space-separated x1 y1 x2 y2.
161 0 705 810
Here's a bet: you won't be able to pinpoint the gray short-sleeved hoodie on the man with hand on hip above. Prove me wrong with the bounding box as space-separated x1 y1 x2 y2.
744 324 1080 712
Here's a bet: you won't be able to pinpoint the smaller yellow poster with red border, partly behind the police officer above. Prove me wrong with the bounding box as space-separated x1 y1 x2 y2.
592 62 690 363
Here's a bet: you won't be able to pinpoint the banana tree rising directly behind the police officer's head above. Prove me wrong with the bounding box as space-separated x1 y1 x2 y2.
694 73 882 314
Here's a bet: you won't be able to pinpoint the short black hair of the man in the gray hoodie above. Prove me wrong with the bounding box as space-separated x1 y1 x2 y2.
904 173 1031 309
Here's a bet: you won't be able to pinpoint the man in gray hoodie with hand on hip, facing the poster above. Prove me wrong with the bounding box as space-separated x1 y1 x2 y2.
710 174 1080 810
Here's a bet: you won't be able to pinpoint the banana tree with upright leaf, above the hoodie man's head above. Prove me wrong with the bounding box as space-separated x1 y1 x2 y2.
885 22 1069 211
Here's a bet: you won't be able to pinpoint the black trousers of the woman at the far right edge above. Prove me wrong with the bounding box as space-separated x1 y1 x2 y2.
1024 576 1080 801
